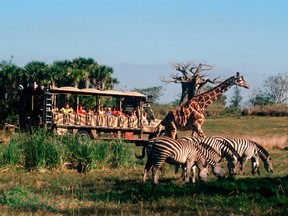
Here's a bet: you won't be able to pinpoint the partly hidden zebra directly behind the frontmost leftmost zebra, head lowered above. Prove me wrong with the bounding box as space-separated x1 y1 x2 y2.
175 136 225 181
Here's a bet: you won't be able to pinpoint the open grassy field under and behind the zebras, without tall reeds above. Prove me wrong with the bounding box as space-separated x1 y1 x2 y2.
0 117 288 215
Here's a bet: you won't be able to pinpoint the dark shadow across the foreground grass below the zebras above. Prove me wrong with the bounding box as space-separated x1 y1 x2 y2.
3 176 288 215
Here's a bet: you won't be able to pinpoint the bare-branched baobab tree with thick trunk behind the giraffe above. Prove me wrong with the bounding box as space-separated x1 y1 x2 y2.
161 62 219 105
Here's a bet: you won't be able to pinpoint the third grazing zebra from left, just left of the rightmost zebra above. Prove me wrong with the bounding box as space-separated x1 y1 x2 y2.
181 136 241 175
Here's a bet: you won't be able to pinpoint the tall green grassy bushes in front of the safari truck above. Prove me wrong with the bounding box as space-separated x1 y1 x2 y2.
0 129 135 172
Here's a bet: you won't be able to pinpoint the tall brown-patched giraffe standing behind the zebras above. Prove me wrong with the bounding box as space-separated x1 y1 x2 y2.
156 72 249 139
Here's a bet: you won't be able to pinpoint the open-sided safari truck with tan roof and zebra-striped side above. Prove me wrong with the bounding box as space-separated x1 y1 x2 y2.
19 83 160 145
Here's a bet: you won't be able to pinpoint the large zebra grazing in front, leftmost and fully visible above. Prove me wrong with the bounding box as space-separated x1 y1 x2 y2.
136 136 208 184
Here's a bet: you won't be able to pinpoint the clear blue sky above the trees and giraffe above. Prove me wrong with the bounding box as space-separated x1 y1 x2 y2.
0 0 288 102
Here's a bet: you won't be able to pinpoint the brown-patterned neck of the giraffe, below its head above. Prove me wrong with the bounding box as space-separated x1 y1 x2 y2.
191 76 235 109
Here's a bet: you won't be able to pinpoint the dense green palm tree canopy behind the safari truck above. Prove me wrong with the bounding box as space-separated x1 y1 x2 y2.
0 57 118 120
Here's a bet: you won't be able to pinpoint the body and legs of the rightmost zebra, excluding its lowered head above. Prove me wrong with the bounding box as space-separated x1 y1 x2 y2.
214 136 259 175
